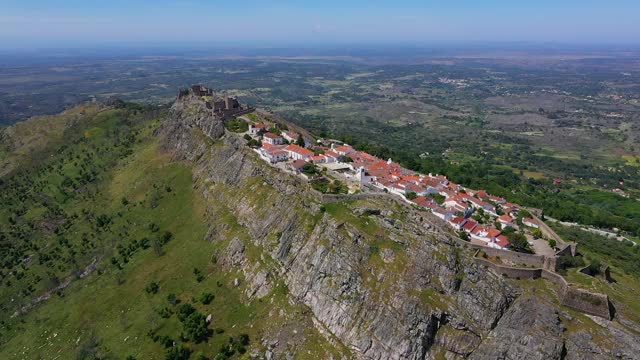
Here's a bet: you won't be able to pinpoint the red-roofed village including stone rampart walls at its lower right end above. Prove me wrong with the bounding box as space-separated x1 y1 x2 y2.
202 86 613 319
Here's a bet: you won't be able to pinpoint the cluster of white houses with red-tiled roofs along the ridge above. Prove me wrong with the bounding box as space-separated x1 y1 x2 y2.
249 128 539 249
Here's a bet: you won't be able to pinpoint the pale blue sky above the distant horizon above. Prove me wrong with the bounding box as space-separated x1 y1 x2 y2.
0 0 640 48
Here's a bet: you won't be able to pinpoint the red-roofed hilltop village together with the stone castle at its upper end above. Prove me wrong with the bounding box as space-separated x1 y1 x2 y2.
178 85 561 255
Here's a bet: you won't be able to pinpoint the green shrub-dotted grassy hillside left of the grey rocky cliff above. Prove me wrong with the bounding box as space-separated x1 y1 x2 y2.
0 107 332 359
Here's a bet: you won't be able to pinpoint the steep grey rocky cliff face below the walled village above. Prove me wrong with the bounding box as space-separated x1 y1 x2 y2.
159 93 638 359
